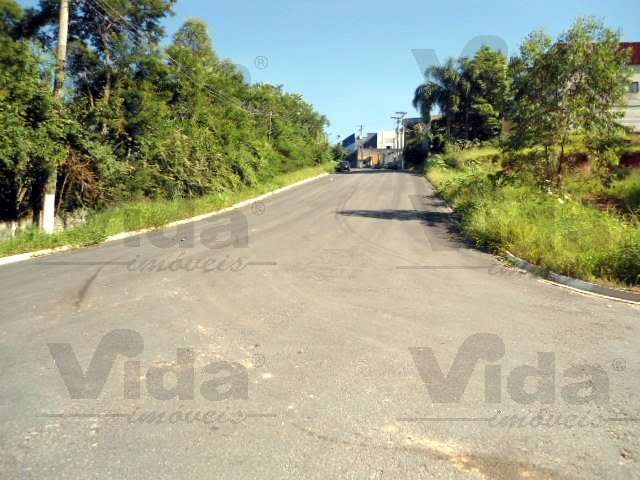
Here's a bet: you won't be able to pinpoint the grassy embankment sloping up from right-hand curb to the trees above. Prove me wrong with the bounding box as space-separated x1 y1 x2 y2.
427 147 640 286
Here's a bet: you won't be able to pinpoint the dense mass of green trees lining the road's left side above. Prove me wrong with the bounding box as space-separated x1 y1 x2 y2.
0 0 332 232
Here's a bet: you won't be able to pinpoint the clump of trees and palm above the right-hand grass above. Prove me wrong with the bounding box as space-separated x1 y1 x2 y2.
409 18 637 182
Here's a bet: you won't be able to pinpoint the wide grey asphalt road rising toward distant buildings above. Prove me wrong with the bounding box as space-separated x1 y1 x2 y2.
0 171 640 480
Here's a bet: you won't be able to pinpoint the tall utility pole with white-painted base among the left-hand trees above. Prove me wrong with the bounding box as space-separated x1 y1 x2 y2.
39 0 69 233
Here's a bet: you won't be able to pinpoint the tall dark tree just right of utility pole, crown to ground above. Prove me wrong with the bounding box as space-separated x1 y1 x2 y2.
23 0 175 204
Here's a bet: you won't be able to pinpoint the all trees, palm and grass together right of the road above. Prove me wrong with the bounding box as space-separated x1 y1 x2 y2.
415 19 640 286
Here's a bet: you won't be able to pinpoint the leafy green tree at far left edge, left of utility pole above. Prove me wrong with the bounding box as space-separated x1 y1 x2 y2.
0 0 66 220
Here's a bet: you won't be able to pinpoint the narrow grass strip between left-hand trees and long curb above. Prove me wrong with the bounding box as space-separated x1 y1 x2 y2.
0 163 334 257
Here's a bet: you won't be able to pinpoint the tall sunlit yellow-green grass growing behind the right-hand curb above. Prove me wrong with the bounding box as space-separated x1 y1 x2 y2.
427 158 640 285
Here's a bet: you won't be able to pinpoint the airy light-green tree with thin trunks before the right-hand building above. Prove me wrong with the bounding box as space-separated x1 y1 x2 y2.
509 18 630 186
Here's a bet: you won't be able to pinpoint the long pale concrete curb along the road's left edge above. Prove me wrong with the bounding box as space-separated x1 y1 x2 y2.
0 173 329 267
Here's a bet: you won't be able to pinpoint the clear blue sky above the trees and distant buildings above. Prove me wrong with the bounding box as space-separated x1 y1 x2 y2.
21 0 640 140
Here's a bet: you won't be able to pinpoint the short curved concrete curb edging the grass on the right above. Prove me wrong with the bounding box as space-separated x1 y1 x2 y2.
503 250 640 305
